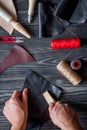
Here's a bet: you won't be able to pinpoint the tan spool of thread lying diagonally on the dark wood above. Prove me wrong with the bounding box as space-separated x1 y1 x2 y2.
57 60 82 86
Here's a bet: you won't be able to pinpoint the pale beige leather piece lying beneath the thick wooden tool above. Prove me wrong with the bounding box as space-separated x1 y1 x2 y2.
0 0 17 34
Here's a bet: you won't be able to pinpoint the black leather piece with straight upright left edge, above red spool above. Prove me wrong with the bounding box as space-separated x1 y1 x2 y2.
38 2 65 37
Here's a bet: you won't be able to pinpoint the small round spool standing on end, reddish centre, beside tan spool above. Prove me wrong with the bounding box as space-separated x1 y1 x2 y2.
70 59 82 70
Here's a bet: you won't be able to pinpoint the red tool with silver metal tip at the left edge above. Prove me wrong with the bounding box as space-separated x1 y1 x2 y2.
0 36 24 43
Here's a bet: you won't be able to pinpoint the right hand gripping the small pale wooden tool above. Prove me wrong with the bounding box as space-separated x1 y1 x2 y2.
49 102 82 130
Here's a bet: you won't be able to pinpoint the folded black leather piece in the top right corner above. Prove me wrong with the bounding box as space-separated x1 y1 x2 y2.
55 0 87 24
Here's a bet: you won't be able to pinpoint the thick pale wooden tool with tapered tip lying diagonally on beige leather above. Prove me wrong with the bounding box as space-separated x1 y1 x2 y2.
0 6 31 38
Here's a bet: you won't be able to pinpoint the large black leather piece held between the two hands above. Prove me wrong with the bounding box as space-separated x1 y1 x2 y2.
23 70 61 130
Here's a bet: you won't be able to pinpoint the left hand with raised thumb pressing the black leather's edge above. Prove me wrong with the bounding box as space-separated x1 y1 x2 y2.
3 88 28 130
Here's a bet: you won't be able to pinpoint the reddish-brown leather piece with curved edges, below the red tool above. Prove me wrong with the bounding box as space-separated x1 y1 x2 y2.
0 45 35 73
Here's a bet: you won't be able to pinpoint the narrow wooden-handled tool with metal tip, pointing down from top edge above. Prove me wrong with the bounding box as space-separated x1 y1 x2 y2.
28 0 36 23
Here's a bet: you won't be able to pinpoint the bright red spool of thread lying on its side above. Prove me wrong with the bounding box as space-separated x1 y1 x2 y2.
51 38 80 49
